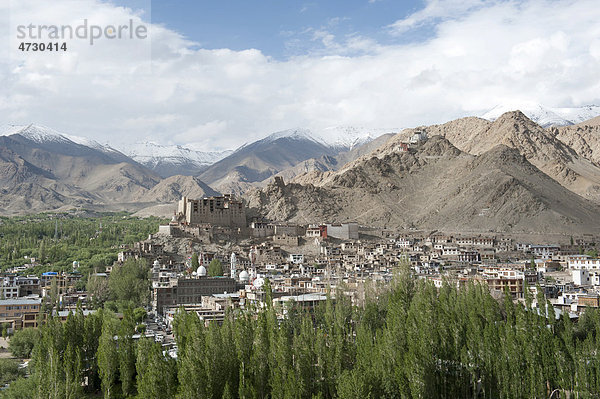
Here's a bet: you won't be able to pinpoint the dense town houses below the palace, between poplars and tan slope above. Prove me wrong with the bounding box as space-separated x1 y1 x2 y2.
136 203 600 322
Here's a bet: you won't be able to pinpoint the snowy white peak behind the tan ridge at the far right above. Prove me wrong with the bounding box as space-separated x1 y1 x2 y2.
481 105 600 128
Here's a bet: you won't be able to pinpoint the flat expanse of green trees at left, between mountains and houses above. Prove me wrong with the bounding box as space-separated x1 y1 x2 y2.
0 212 165 277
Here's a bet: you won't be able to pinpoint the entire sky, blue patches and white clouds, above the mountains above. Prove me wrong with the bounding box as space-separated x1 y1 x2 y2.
0 0 600 151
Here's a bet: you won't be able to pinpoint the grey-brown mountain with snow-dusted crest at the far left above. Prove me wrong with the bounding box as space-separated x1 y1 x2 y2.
0 125 220 214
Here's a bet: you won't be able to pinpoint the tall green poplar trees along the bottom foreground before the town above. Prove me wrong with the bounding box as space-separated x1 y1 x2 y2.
4 272 600 399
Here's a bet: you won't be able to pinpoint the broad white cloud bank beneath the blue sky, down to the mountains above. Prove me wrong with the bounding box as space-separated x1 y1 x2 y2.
0 0 600 150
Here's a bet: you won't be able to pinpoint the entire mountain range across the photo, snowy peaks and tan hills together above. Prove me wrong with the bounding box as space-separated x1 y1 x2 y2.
0 107 600 234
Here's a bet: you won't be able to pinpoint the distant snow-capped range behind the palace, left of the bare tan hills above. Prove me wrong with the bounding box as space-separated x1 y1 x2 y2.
0 124 394 215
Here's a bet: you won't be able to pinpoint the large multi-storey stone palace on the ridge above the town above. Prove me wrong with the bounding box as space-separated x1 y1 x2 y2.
177 194 246 227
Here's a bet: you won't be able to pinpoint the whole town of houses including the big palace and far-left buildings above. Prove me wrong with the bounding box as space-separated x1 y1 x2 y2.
0 196 600 338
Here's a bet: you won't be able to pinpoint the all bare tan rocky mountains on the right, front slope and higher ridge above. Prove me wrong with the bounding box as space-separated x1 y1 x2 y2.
245 111 600 234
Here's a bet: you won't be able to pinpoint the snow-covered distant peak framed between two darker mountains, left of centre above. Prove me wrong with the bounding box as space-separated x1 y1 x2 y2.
124 141 233 177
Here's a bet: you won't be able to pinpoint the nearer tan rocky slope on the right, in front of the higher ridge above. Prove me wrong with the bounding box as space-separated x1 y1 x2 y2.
246 136 600 232
